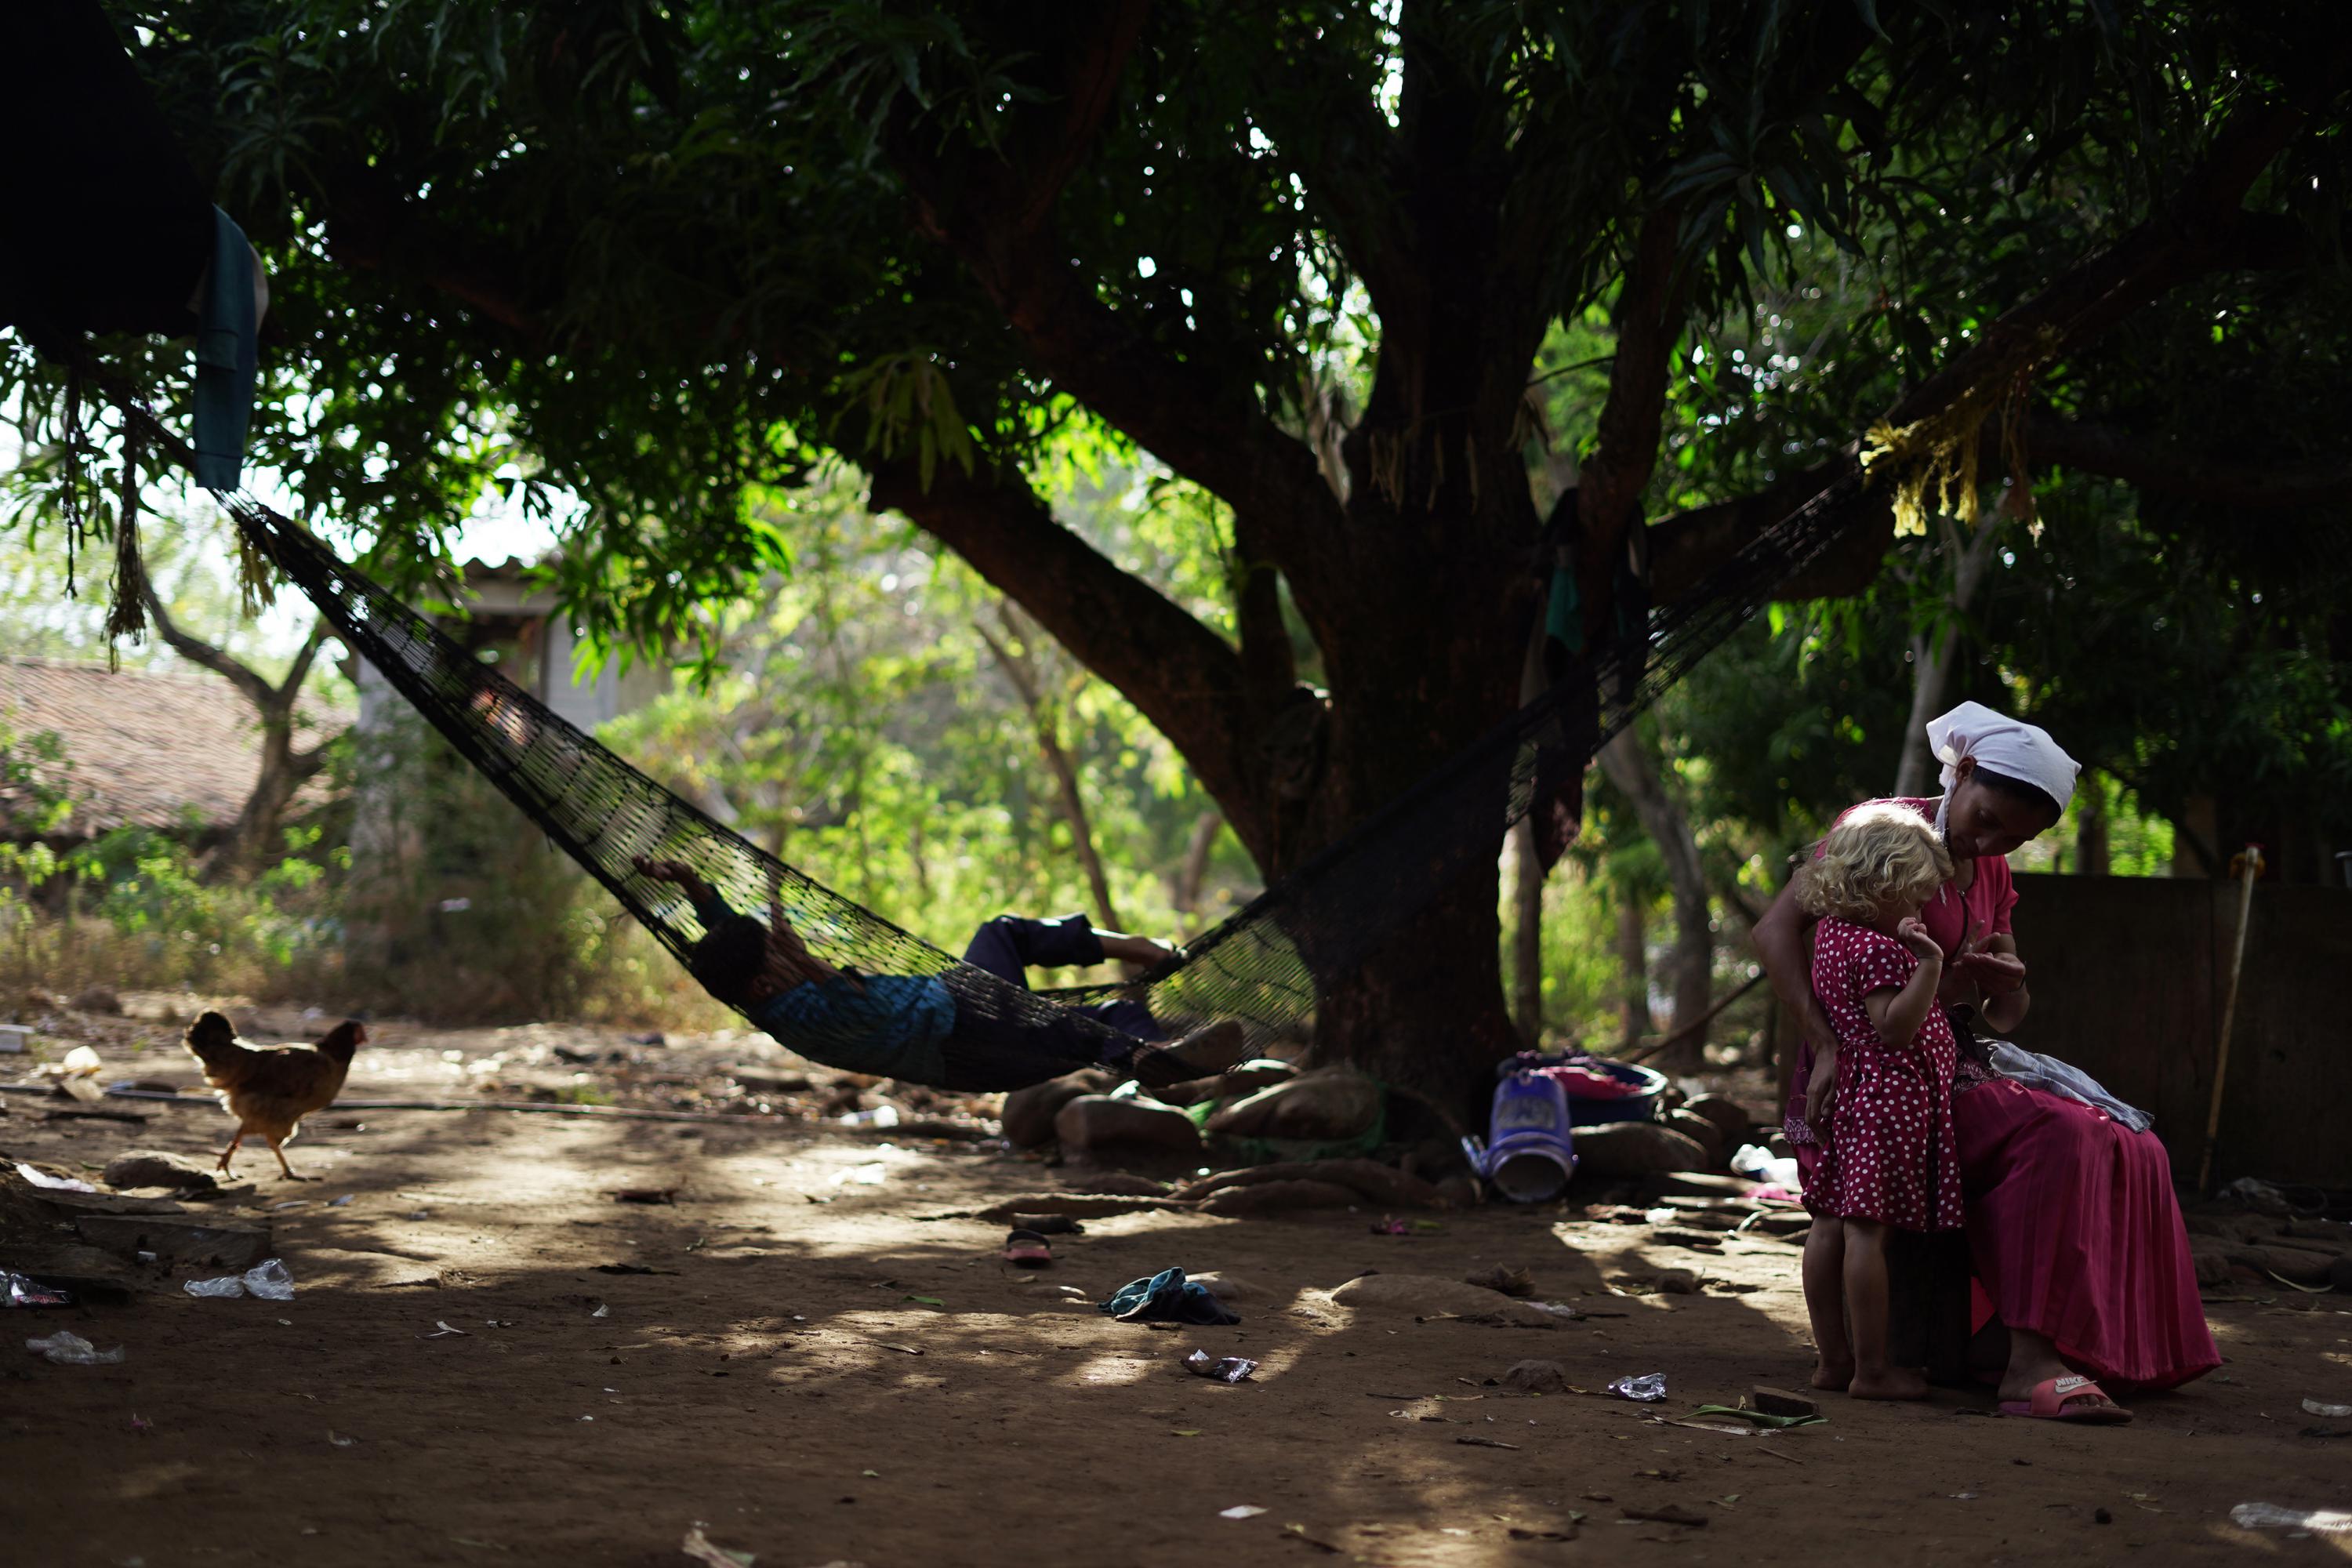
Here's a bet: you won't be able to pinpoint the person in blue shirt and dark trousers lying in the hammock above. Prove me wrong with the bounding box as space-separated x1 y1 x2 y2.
635 855 1247 1093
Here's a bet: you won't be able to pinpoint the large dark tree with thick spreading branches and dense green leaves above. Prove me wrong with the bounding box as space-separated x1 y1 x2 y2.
9 0 2343 1095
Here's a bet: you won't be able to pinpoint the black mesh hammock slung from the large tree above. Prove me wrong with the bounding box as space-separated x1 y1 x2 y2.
125 405 1860 1093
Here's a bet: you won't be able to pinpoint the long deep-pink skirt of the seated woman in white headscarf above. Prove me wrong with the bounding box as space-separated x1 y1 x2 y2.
1952 1081 2220 1389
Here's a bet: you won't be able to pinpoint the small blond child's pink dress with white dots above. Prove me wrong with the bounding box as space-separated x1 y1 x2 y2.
1804 919 1962 1229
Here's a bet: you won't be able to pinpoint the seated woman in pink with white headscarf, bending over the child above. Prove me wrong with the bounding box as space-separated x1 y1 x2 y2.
1755 703 2220 1422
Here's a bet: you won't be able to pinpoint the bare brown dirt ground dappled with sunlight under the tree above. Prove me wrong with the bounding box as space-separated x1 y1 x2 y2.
0 1018 2352 1568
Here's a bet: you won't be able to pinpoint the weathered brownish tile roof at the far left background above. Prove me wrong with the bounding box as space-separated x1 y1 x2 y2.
0 656 353 844
